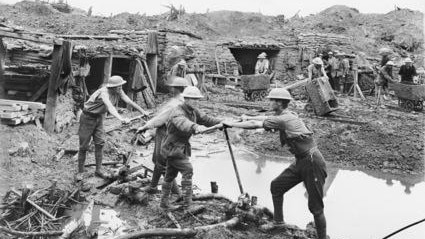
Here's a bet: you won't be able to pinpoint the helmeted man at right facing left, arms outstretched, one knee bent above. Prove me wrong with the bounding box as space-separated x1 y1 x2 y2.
223 88 327 239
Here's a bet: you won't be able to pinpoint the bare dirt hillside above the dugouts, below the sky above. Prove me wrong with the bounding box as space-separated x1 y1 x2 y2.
0 1 424 61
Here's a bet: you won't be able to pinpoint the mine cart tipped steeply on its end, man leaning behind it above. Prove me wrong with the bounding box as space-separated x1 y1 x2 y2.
305 77 338 116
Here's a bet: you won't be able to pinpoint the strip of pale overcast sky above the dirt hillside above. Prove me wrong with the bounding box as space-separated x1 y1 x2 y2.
0 0 425 17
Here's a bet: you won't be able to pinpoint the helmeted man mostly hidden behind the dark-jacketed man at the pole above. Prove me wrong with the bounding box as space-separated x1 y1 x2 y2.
137 77 187 196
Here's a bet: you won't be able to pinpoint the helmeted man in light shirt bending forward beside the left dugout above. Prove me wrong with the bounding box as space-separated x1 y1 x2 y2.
78 76 147 177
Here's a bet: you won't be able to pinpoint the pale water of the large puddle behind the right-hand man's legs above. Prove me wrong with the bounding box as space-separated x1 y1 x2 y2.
192 151 425 239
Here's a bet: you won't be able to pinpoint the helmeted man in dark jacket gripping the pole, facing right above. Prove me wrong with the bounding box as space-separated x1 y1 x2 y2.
160 86 221 210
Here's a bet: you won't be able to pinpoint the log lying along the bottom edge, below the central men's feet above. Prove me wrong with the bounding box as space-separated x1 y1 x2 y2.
113 228 197 239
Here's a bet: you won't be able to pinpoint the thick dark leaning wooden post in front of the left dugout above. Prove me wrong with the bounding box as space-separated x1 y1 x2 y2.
43 41 65 133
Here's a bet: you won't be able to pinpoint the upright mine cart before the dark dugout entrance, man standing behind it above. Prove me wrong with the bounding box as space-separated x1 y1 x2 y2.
241 74 270 101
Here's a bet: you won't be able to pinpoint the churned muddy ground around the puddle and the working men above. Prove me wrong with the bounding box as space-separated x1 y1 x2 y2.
0 85 424 238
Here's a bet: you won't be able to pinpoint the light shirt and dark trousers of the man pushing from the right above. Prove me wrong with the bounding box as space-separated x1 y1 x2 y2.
263 110 327 215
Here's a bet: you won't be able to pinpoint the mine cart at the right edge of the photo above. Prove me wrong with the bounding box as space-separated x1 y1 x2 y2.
388 82 425 111
